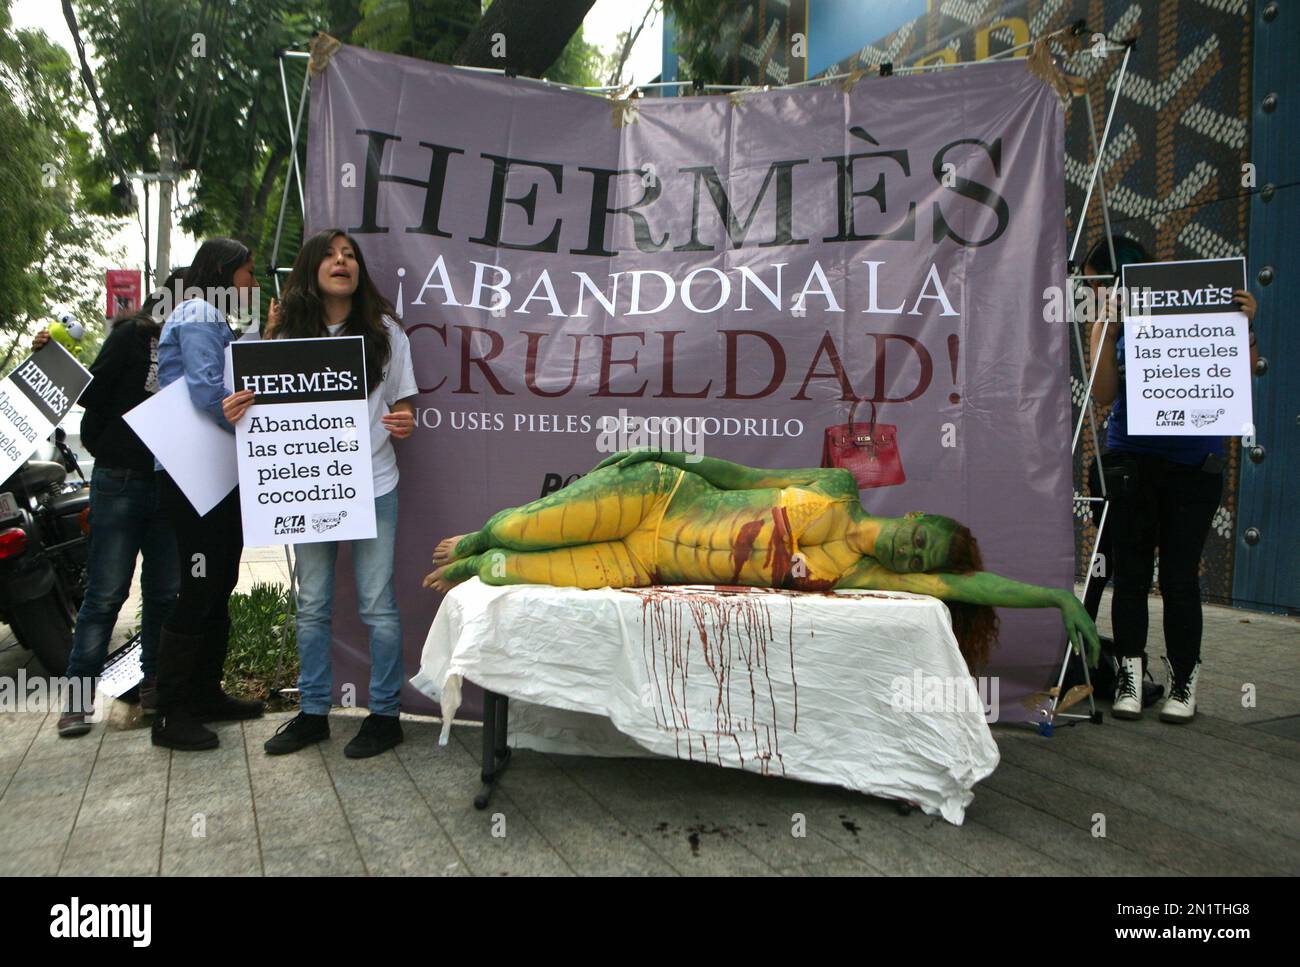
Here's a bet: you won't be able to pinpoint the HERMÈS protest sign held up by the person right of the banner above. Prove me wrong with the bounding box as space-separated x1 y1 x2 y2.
1123 259 1255 437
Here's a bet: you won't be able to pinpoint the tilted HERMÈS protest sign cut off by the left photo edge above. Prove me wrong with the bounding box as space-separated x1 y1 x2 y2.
0 339 91 481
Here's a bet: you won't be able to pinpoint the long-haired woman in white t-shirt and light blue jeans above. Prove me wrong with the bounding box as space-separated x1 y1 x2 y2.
230 229 417 759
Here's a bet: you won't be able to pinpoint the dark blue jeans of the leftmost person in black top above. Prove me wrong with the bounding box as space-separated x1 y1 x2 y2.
68 467 181 678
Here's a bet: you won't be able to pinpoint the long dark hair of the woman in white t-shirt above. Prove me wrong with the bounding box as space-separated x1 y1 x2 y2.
276 229 397 393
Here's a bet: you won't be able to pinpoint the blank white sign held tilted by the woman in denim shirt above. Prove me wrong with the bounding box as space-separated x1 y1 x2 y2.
122 377 239 517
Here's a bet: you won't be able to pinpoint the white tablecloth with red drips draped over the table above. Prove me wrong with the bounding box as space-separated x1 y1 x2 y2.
412 578 998 824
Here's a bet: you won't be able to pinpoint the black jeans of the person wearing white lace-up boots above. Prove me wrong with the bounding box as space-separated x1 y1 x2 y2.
1105 454 1223 677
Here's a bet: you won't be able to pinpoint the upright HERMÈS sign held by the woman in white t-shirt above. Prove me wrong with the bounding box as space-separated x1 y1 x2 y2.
231 335 376 547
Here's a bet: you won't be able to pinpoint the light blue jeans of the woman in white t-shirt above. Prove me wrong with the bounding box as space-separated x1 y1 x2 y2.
294 489 404 715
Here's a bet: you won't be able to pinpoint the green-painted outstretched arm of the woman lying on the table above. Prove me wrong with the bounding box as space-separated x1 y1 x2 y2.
836 558 1101 665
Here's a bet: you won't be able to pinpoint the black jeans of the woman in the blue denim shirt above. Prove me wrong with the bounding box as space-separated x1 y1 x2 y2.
159 473 243 634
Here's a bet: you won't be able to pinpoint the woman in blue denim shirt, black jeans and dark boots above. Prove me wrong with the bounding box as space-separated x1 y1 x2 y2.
153 238 263 751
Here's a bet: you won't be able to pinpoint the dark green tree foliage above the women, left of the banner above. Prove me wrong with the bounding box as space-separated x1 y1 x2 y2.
77 0 325 285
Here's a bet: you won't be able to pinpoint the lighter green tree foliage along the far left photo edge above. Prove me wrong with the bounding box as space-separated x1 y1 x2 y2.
0 0 117 358
